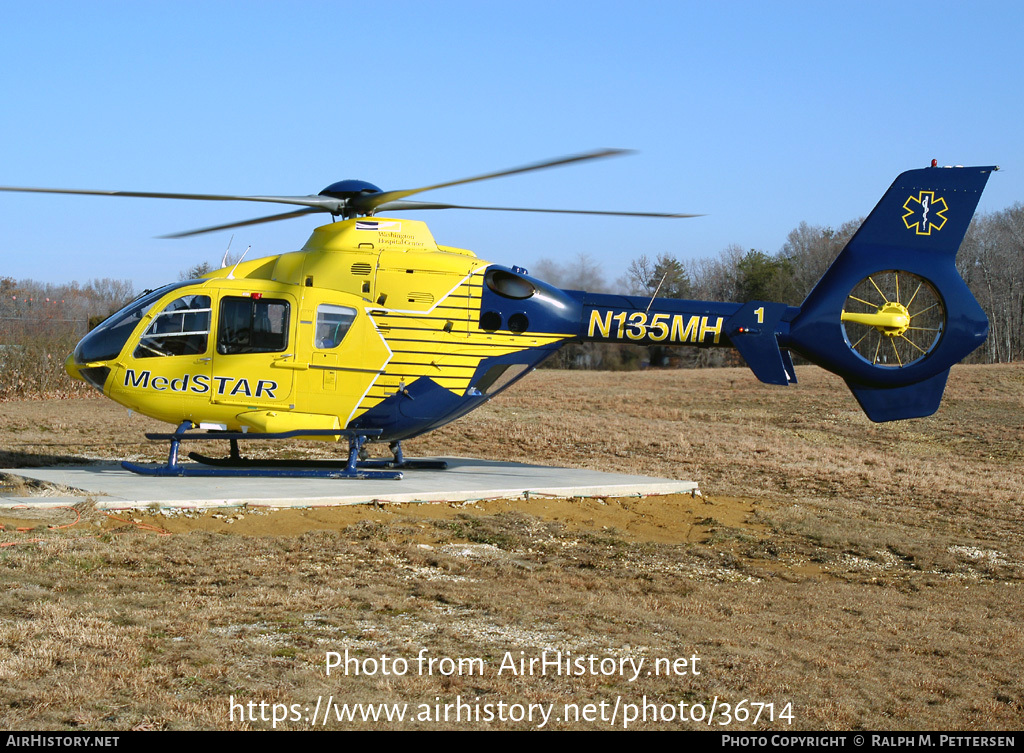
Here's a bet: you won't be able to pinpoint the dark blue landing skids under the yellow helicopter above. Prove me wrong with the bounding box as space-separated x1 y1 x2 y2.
121 421 447 479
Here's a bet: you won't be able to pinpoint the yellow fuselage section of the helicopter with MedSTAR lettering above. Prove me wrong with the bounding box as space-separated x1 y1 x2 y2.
68 219 569 438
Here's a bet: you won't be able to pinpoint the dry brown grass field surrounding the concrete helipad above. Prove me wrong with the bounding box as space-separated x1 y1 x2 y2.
0 365 1024 730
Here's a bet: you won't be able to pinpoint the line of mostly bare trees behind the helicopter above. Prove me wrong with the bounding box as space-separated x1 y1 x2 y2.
0 204 1024 399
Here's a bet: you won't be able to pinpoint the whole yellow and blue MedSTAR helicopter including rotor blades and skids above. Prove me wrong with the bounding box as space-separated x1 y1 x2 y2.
0 150 998 478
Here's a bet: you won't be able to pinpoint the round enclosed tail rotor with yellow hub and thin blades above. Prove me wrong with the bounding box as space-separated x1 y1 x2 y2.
842 269 946 369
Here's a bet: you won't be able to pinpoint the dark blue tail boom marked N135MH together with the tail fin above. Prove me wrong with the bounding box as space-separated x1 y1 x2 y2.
569 167 997 421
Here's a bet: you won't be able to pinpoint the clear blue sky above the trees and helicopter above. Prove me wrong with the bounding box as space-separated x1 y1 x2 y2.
0 1 1024 288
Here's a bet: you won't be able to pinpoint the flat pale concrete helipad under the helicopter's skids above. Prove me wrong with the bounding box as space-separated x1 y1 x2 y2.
0 458 699 509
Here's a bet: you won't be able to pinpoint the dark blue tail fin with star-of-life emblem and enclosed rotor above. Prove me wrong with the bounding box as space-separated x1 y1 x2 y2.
780 167 996 421
